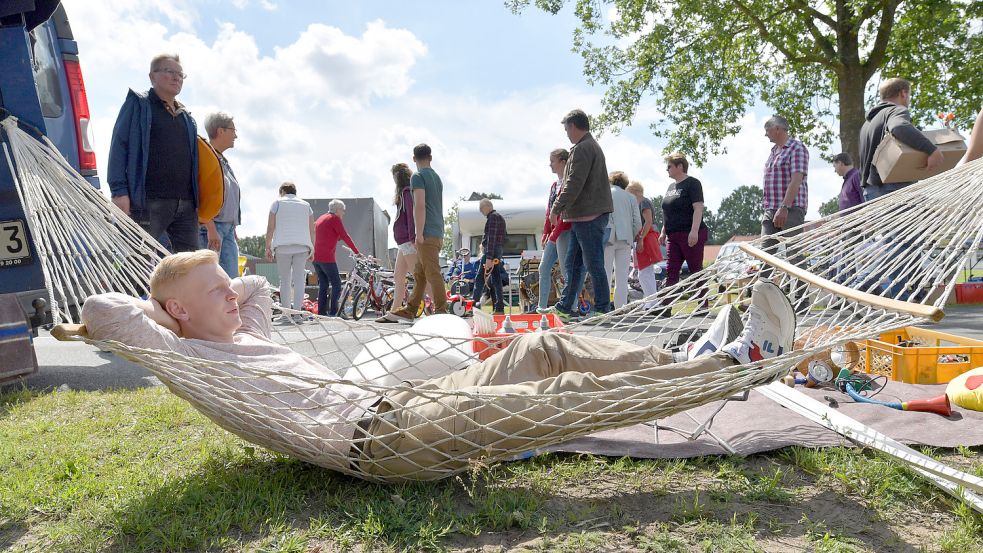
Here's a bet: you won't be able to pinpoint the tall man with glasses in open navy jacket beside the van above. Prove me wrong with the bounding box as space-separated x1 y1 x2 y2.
107 54 198 252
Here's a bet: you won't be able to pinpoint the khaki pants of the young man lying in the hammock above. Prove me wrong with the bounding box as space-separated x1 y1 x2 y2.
358 332 736 480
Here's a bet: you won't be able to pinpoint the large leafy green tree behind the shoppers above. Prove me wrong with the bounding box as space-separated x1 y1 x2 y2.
506 0 983 163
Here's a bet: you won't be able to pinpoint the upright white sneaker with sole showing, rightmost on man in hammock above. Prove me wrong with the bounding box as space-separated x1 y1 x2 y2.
720 279 795 365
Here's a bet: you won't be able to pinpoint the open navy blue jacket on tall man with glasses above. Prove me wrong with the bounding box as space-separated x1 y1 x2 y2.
106 89 198 211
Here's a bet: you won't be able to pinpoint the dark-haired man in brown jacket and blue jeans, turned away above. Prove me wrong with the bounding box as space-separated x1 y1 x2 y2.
550 109 614 320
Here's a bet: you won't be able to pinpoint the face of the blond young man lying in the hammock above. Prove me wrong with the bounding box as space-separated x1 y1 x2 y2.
167 264 242 341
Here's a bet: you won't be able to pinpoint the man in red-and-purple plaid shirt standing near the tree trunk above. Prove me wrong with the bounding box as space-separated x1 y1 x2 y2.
761 115 809 236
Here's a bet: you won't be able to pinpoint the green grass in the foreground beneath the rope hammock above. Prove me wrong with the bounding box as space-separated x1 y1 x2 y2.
0 388 983 552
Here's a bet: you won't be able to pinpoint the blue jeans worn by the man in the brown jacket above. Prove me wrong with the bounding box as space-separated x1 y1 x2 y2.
556 213 611 313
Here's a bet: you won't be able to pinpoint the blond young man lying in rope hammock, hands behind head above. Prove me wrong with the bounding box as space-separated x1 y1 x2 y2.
82 250 795 480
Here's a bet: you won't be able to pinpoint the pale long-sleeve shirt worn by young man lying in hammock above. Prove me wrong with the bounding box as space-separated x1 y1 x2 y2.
82 275 379 468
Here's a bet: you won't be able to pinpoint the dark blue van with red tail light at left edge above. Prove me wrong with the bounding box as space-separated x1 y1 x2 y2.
0 0 99 334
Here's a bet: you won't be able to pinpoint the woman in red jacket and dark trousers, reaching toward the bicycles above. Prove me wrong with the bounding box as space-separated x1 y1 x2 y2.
314 200 358 317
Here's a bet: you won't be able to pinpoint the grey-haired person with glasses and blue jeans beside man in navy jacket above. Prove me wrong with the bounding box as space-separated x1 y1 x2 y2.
199 111 242 278
